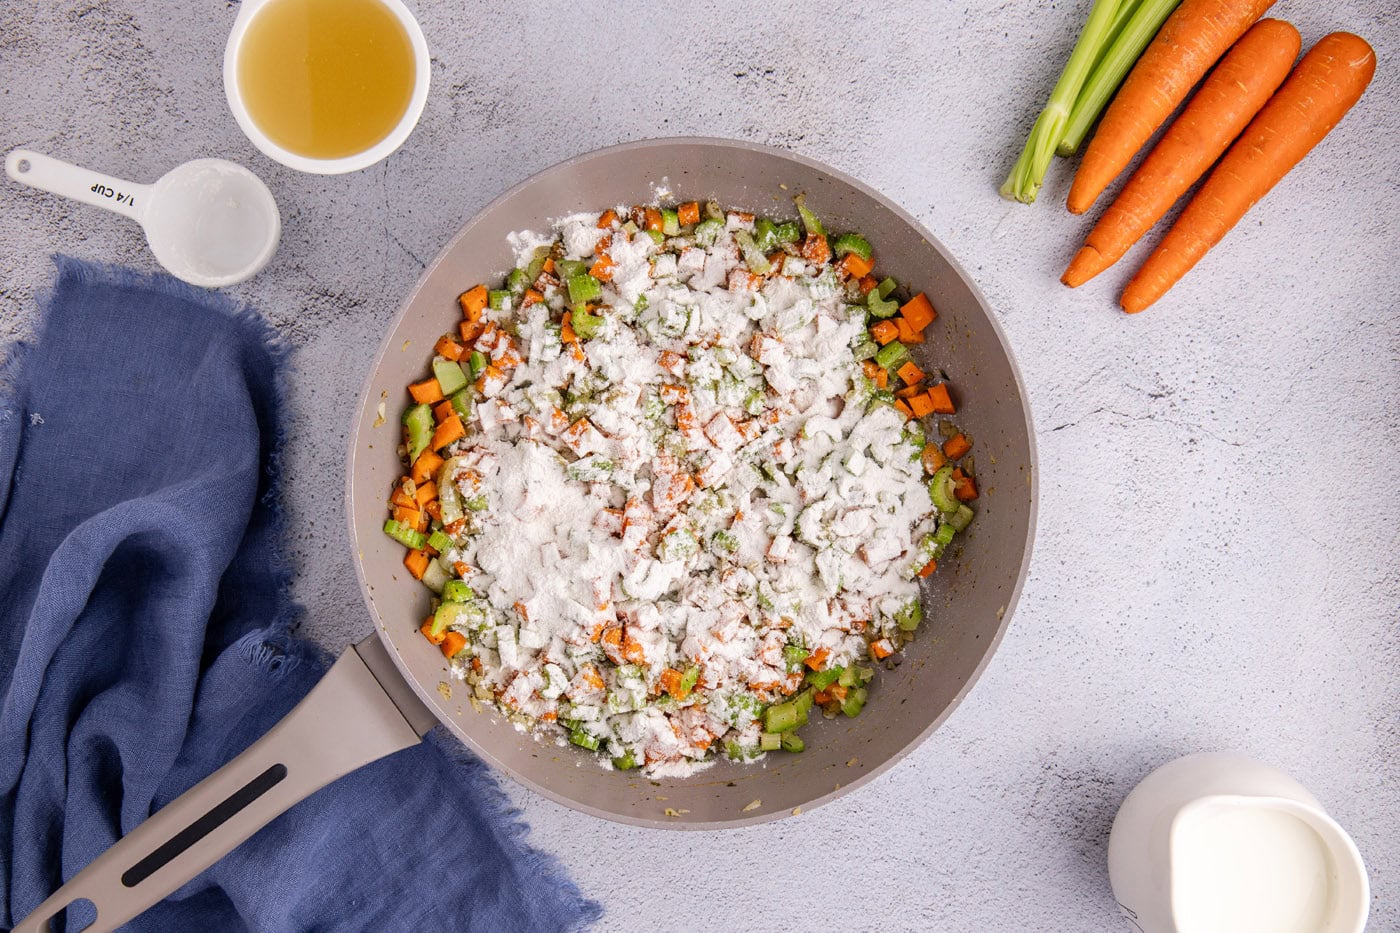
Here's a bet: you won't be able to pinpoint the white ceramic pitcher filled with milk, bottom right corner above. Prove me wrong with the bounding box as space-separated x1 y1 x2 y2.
1109 754 1371 933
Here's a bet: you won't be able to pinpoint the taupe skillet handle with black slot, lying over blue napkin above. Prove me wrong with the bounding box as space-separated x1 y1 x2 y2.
14 635 435 933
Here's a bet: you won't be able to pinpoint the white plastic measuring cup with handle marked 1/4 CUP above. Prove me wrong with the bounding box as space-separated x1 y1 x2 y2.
4 148 281 289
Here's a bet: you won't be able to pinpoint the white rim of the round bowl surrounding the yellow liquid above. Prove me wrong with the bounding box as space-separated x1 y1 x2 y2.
215 0 430 175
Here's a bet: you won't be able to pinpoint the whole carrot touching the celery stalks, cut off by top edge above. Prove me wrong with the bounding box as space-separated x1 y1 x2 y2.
1068 0 1274 214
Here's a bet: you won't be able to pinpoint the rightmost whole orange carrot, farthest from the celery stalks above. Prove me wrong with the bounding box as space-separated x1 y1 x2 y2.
1123 32 1376 314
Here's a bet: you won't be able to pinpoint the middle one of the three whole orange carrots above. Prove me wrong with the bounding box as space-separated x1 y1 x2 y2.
1060 20 1302 289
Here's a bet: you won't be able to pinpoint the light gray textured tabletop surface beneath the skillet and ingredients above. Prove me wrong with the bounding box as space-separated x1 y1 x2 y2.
0 0 1400 930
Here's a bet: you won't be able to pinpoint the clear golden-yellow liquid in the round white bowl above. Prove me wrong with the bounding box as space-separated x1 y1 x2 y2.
237 0 414 158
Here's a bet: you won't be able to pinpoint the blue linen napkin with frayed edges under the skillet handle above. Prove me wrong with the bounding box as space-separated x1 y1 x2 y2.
0 258 599 933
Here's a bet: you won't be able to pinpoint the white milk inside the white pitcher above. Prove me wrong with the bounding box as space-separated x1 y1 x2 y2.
1172 801 1337 933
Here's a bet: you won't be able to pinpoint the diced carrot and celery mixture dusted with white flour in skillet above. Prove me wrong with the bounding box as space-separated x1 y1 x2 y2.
385 198 977 776
